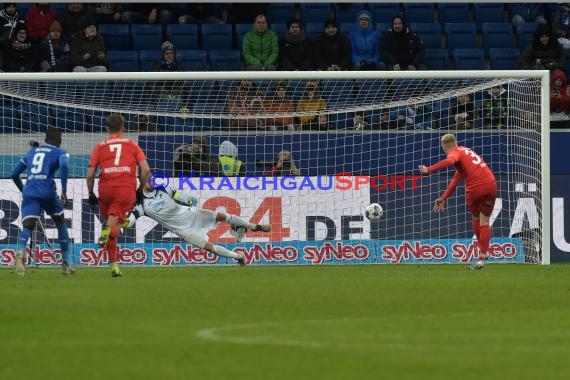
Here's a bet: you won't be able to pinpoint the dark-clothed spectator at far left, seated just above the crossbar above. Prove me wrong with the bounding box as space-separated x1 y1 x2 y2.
3 23 40 73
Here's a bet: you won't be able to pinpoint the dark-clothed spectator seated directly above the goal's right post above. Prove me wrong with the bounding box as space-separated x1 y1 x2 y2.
520 24 566 72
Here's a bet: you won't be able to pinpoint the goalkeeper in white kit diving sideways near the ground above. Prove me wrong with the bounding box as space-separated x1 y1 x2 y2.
99 183 271 265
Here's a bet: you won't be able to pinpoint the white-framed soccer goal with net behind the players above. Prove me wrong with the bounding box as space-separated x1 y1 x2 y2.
0 71 550 266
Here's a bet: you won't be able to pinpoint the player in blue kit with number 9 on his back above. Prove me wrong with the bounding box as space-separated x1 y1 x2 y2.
12 127 75 276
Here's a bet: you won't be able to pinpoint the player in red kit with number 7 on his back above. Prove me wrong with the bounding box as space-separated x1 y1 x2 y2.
87 114 150 277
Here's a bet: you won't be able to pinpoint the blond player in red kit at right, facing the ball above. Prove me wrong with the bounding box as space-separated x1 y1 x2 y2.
418 133 497 269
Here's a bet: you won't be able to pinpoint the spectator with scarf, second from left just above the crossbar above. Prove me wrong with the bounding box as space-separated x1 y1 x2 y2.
40 20 69 72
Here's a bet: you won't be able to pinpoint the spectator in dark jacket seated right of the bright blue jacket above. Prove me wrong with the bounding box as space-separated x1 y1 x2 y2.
380 16 425 71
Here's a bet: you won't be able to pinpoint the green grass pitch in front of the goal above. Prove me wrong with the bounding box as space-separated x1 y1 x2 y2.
0 265 570 380
